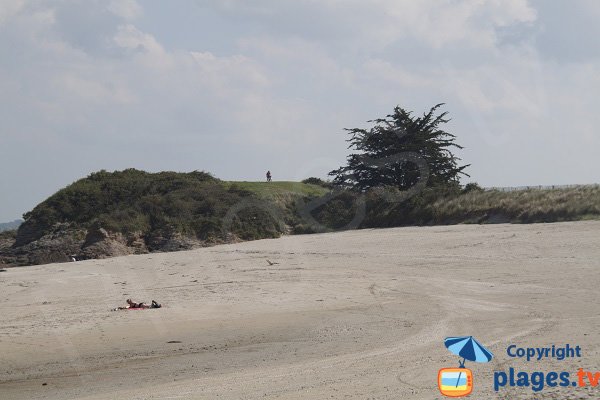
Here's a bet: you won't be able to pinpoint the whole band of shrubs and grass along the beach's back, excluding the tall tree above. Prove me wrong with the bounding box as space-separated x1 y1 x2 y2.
15 169 600 255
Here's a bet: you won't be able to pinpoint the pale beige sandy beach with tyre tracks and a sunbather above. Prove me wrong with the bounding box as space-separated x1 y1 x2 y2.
0 222 600 400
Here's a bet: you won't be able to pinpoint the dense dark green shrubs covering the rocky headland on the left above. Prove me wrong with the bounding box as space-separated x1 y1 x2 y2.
17 169 282 245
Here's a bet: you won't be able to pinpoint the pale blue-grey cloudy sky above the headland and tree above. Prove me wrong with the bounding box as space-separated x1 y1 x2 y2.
0 0 600 221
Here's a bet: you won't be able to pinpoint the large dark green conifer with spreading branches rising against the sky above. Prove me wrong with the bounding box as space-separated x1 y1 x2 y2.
329 103 469 191
